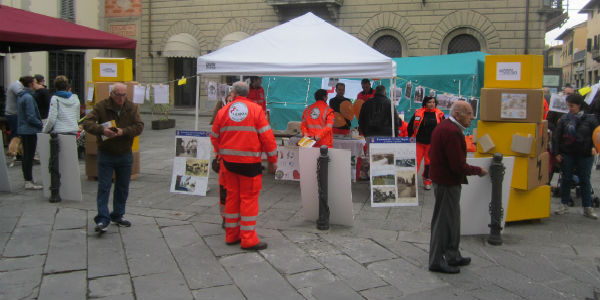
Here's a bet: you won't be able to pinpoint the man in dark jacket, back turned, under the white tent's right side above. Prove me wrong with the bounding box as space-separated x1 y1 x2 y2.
358 85 400 137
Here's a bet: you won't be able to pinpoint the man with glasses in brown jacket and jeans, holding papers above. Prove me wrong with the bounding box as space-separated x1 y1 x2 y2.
83 83 144 233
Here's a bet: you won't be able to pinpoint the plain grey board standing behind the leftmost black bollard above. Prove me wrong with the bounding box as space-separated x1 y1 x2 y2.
37 133 83 201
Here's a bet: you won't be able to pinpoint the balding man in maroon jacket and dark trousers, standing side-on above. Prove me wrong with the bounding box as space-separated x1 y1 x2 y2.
429 101 487 273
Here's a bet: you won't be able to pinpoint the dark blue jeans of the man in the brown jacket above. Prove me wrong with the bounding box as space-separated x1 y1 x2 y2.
94 150 133 224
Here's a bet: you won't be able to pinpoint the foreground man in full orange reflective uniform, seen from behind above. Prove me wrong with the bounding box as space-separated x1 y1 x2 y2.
211 82 277 250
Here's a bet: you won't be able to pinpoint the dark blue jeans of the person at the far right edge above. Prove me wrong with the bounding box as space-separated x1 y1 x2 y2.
560 155 594 207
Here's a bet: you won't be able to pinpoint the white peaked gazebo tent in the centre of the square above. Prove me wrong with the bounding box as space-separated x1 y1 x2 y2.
195 13 396 130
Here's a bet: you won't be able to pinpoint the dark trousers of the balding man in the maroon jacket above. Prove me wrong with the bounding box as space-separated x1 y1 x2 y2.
429 183 462 267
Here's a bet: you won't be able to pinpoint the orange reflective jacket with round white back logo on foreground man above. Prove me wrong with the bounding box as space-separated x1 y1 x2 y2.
210 96 277 163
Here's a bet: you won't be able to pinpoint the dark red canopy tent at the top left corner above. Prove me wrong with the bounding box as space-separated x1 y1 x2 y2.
0 5 137 53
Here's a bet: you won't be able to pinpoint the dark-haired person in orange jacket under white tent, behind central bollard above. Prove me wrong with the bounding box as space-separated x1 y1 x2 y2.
300 89 333 148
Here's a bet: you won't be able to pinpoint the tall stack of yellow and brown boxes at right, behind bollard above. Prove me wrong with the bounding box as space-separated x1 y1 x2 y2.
475 55 550 222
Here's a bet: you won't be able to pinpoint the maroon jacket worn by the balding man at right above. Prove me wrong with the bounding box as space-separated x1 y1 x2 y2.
429 119 481 185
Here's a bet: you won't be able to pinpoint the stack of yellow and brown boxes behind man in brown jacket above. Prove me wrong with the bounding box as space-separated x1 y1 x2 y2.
85 58 140 180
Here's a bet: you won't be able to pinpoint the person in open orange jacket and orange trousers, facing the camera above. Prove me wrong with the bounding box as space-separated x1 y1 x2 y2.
408 96 444 190
